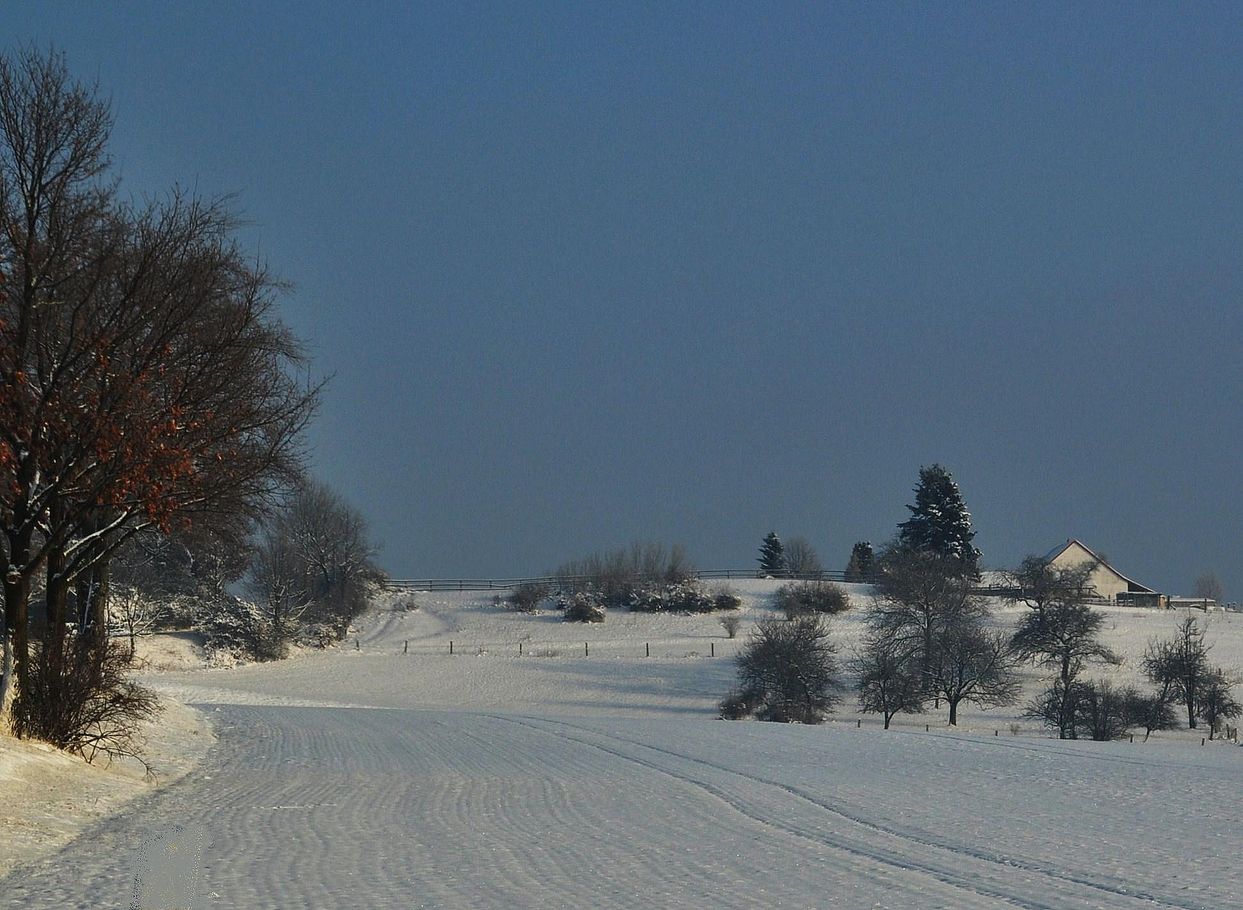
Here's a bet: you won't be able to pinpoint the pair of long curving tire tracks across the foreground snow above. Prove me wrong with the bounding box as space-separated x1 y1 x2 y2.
492 715 1212 910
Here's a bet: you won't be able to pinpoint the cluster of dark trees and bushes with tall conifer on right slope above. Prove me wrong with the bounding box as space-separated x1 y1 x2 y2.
722 465 1241 738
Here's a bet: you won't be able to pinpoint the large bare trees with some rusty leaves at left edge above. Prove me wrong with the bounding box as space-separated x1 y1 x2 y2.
0 48 377 760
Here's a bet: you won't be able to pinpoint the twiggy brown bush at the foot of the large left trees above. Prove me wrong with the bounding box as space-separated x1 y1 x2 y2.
12 635 159 771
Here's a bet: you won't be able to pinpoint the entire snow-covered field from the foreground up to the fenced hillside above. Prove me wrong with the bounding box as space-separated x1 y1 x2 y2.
0 582 1243 910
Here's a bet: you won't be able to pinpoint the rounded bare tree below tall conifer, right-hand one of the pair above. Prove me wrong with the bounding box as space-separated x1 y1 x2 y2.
927 615 1019 726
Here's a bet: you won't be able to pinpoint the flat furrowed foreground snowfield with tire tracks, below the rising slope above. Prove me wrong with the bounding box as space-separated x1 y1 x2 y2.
0 706 1238 910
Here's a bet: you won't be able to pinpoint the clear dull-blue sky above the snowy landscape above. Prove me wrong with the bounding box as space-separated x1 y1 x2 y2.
9 2 1243 598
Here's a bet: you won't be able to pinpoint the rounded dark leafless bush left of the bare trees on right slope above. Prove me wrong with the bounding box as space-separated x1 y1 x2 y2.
722 615 840 724
